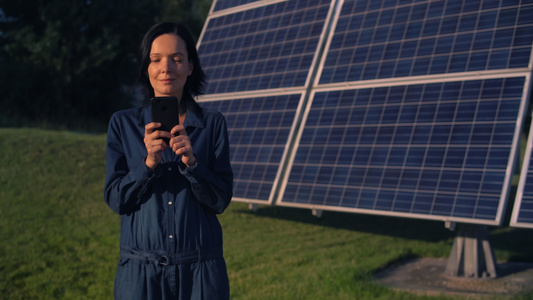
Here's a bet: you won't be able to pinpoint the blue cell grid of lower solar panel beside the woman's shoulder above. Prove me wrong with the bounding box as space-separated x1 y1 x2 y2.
201 94 301 202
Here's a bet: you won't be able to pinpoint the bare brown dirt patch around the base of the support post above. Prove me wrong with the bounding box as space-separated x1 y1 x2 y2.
376 258 533 299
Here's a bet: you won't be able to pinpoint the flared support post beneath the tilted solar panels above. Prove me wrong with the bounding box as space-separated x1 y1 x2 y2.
445 224 497 279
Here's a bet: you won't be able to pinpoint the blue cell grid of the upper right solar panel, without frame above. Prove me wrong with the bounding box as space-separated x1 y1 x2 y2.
320 1 533 84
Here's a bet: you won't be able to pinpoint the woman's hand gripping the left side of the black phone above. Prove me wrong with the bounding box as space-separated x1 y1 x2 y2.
144 122 172 170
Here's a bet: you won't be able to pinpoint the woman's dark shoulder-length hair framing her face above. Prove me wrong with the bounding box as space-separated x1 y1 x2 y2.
139 22 206 110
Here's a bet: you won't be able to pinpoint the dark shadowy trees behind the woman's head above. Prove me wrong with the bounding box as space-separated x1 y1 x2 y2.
0 0 211 128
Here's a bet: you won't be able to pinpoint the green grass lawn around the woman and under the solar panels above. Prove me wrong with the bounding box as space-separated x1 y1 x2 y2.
0 129 533 299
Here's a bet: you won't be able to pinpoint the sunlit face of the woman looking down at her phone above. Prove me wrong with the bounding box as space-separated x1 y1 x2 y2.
148 34 193 100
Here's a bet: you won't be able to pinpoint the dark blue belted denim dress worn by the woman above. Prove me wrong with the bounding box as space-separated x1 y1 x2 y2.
104 106 233 299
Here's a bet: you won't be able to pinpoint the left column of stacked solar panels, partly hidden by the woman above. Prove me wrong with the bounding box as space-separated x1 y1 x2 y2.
198 0 331 203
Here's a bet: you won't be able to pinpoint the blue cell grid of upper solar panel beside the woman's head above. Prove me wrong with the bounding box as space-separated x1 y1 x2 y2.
199 0 330 94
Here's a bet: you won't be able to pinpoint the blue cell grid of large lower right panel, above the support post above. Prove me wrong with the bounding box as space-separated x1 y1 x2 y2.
282 78 524 220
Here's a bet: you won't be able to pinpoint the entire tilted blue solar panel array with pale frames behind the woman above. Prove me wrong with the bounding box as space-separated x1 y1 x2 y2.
198 0 533 224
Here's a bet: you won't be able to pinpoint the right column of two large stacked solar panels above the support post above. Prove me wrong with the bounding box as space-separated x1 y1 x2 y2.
277 1 533 224
